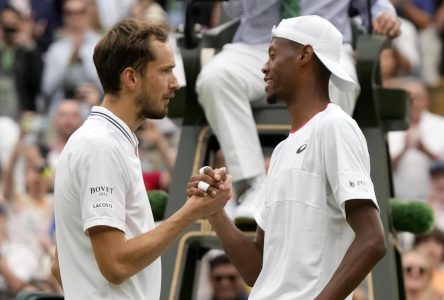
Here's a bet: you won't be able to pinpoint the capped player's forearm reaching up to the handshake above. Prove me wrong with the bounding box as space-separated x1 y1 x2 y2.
208 212 263 286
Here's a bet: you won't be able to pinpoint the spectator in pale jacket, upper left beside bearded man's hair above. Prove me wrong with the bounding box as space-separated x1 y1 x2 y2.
42 0 101 111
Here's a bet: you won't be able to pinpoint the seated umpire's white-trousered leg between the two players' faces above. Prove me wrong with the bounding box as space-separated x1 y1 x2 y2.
196 44 267 185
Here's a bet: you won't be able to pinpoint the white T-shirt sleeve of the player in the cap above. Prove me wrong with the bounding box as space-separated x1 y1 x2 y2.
323 118 379 216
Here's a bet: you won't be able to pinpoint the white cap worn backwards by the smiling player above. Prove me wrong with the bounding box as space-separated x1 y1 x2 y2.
271 15 356 91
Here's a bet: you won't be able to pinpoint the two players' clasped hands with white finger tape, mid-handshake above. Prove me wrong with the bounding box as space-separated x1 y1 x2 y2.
185 166 232 219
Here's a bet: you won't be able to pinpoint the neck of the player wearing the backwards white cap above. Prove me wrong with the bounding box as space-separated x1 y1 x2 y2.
288 84 330 131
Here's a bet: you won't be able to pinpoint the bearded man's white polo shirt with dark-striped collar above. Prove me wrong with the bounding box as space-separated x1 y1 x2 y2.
54 107 161 300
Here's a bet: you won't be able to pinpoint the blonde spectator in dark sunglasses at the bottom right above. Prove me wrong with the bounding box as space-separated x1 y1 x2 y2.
402 249 443 300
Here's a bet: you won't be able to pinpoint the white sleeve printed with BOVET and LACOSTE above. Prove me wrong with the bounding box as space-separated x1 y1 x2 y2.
76 140 129 232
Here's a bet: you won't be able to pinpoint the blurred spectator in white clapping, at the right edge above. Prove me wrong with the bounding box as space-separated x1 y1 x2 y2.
388 78 444 201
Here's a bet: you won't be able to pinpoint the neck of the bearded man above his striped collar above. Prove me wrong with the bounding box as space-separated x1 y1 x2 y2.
102 94 144 132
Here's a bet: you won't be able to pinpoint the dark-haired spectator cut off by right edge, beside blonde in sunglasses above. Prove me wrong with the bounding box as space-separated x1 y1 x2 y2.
413 229 444 295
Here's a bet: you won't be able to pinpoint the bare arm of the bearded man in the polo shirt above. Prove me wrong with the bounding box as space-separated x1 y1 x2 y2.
88 186 229 284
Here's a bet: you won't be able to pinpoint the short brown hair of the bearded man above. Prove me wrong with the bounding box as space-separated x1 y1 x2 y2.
93 19 169 95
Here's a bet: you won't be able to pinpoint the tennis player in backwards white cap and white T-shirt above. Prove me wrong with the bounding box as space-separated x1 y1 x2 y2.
188 16 386 300
